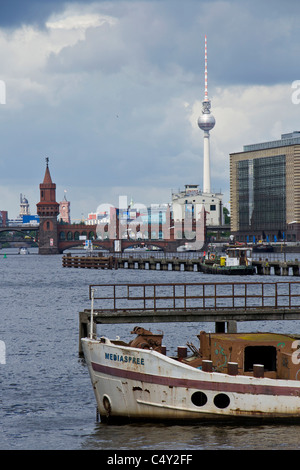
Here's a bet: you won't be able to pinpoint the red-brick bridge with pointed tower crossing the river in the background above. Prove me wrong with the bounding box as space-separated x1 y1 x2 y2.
5 163 205 254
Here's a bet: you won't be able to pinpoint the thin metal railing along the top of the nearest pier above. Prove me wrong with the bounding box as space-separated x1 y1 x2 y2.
89 282 300 314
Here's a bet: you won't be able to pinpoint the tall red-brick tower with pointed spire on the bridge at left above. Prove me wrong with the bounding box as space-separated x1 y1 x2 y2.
36 158 59 255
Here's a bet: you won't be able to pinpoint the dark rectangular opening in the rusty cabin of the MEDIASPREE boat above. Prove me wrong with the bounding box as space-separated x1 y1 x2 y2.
244 346 276 372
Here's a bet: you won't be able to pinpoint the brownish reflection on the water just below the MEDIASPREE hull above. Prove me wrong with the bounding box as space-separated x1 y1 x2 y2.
82 424 300 451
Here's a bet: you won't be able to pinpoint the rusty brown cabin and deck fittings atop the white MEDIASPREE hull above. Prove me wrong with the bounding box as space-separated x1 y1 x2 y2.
129 327 300 380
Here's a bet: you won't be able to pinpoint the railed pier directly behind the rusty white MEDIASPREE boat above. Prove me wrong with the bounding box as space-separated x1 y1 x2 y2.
79 281 300 353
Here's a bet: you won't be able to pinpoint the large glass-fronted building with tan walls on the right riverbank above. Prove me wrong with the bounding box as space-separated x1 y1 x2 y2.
230 131 300 242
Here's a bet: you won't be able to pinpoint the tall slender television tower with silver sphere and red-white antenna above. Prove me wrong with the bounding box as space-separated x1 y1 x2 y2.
198 35 216 193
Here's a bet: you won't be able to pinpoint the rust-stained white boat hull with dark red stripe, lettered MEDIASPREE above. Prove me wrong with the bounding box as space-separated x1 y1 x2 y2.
82 338 300 422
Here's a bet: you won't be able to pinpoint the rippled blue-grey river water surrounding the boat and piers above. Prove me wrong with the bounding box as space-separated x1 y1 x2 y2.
0 249 300 451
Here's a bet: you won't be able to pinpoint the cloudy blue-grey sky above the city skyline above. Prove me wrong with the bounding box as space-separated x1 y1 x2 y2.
0 0 300 220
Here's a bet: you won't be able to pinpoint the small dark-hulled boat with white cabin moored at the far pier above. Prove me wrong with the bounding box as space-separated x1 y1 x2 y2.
200 246 256 276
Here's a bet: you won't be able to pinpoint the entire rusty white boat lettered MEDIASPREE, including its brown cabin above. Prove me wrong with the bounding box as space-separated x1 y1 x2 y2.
82 327 300 423
